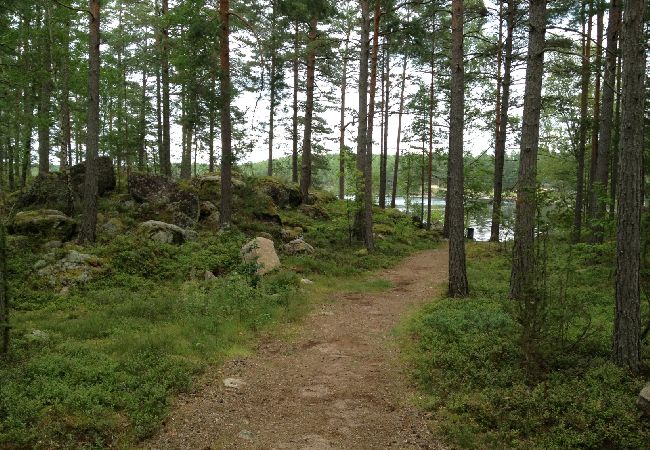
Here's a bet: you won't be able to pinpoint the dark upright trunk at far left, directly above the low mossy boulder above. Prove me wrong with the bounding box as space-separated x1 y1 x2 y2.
38 5 52 174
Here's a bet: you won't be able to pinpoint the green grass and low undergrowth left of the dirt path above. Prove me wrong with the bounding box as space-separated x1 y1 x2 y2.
0 197 434 448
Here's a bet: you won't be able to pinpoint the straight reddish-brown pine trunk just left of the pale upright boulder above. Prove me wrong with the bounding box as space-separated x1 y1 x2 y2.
219 0 232 228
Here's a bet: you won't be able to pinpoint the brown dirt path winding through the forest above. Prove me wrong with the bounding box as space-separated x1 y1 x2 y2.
146 247 447 449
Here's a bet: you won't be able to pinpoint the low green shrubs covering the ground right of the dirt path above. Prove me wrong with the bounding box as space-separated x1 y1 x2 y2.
402 245 650 449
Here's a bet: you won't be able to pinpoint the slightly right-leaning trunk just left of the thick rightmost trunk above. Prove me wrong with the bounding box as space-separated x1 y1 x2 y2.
592 0 621 243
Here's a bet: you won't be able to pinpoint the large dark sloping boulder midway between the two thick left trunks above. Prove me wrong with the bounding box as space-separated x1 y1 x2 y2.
128 173 200 226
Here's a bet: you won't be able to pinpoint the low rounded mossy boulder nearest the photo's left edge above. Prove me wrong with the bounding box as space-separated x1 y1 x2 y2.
9 209 77 241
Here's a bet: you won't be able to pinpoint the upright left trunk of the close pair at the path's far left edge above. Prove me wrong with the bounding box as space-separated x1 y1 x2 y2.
354 0 373 248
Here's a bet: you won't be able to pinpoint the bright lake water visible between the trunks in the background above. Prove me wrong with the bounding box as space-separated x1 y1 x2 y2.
387 196 514 241
